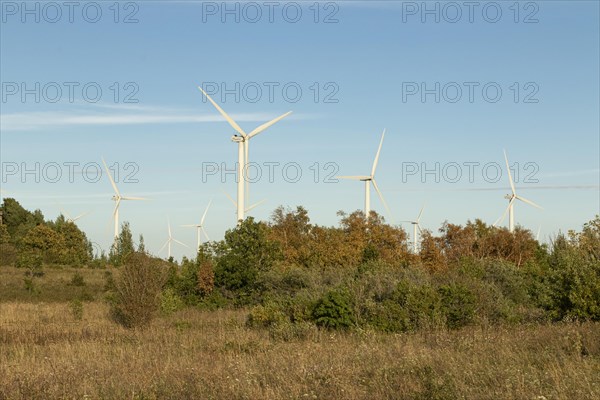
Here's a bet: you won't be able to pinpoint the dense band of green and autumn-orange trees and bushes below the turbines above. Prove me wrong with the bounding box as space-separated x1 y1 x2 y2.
0 199 600 339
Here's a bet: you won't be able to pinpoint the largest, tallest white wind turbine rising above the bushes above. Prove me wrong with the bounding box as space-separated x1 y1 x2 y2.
198 86 292 221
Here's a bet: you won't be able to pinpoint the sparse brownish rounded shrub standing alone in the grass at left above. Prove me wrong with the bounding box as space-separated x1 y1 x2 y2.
110 252 167 328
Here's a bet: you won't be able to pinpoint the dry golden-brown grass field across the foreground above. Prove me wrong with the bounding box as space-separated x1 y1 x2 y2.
0 302 600 400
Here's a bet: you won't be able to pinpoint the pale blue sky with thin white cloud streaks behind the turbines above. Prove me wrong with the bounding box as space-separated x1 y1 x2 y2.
0 1 600 257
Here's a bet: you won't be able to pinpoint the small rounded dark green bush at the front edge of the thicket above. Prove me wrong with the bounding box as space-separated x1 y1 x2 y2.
312 290 354 329
